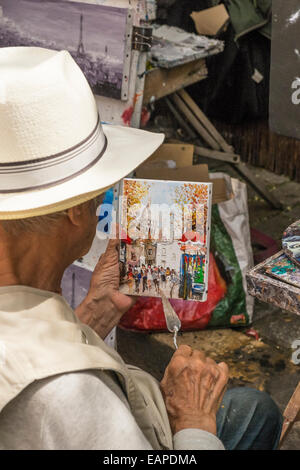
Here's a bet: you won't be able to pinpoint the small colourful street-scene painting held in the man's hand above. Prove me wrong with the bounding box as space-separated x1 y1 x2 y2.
120 179 211 301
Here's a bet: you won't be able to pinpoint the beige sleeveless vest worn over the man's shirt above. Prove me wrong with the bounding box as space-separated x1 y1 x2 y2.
0 286 173 449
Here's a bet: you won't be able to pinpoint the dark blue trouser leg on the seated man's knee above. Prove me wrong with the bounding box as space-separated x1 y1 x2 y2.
217 387 283 450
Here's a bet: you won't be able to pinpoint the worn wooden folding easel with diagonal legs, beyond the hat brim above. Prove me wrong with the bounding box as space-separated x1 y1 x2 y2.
143 59 282 209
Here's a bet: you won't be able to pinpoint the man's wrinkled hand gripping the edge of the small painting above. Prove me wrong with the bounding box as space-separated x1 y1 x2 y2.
75 240 134 339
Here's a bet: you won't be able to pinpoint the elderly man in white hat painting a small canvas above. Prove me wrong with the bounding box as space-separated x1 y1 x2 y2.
0 48 281 450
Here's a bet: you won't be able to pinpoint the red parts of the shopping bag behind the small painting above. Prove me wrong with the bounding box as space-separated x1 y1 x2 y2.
120 253 227 331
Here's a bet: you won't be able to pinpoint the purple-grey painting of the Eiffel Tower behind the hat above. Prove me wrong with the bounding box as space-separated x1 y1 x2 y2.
0 0 130 99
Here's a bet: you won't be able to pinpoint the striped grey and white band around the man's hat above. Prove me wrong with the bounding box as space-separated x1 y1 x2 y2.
0 117 107 193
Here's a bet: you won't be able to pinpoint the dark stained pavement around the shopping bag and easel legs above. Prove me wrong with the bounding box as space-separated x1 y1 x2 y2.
117 161 300 449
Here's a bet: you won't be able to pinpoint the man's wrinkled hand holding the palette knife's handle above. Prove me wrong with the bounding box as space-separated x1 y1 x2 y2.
160 345 228 435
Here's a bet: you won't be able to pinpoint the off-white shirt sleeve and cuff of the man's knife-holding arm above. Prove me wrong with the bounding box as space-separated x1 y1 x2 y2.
0 371 222 450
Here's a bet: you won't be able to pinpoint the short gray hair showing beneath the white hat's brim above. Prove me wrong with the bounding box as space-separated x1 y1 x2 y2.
0 194 103 236
